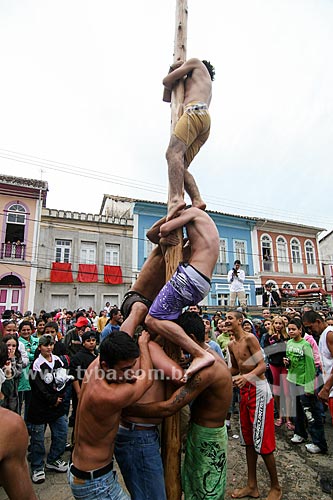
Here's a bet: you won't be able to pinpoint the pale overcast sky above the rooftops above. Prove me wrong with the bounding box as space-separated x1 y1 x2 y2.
0 0 333 234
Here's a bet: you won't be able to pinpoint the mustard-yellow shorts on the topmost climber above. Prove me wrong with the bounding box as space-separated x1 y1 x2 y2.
173 102 210 167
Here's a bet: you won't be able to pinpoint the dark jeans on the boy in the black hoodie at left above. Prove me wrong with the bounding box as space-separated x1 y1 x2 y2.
30 415 68 471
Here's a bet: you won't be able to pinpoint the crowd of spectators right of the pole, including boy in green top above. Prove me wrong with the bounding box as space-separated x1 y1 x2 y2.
211 304 333 453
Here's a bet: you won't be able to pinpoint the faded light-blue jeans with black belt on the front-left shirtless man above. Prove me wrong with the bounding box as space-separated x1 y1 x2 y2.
67 470 130 500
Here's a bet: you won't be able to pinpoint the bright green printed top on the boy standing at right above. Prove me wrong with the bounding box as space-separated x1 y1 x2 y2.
286 338 316 394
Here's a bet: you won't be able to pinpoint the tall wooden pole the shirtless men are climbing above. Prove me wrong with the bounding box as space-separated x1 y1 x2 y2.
162 0 187 500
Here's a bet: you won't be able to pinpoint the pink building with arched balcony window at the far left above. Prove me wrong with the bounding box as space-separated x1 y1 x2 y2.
0 175 48 313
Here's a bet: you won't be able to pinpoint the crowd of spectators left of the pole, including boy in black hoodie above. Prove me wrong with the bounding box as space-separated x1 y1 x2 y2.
0 303 122 484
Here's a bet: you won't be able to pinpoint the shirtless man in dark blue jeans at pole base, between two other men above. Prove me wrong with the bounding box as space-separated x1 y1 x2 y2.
114 342 183 500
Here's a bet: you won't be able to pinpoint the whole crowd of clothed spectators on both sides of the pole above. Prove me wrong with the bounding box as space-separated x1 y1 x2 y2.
0 303 333 494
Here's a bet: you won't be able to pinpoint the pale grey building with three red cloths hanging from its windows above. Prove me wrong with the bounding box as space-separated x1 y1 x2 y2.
35 204 133 313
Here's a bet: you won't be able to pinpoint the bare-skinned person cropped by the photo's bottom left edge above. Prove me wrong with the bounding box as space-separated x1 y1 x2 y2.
0 342 37 500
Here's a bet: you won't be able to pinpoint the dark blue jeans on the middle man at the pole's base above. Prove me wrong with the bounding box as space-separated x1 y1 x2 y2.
114 427 166 500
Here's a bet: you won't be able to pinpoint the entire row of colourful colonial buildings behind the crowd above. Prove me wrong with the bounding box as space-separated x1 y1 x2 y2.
0 176 326 313
